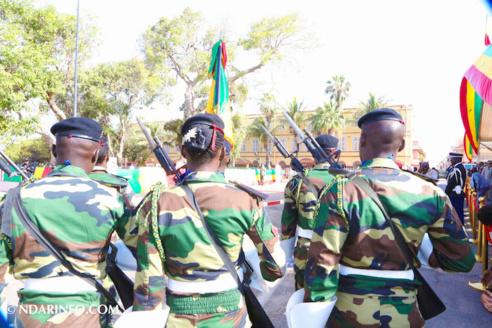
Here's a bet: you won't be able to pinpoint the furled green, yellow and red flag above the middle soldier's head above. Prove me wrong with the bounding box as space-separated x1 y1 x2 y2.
206 40 234 147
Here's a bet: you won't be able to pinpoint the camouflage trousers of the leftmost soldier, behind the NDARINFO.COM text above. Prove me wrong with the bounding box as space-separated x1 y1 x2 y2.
15 290 114 328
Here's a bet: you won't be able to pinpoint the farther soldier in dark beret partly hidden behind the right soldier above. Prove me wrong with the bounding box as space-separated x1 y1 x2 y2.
282 134 338 290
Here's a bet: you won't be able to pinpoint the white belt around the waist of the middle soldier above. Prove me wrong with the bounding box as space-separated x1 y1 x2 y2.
167 269 243 294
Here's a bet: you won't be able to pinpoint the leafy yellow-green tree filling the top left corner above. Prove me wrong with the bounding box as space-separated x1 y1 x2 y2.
0 0 97 131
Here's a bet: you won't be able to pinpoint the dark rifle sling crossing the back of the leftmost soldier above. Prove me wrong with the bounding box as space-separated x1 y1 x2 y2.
14 186 123 312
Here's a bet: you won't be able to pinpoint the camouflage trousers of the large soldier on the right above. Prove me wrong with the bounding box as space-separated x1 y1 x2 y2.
326 291 425 328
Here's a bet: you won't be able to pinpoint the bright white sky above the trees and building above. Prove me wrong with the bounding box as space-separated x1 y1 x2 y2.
40 0 492 166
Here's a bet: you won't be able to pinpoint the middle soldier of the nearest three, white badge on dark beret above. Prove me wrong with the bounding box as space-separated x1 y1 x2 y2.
133 114 285 328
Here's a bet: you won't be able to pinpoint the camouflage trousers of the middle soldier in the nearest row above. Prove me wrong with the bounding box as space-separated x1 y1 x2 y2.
166 306 251 328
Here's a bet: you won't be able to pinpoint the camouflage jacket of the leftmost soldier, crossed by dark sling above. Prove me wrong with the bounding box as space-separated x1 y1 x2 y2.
0 165 137 291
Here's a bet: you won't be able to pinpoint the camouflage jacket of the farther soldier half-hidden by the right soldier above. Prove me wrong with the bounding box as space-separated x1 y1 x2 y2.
282 163 333 240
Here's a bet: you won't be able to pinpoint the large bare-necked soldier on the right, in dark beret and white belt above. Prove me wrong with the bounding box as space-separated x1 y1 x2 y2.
304 109 475 327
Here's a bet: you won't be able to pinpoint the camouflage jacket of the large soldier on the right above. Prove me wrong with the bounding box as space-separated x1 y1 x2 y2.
305 158 475 301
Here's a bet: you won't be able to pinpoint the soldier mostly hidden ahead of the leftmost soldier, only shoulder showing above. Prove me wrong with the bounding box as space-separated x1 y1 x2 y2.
89 137 137 210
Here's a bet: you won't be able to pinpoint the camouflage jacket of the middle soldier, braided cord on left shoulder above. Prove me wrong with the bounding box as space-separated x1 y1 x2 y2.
133 172 285 313
